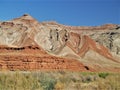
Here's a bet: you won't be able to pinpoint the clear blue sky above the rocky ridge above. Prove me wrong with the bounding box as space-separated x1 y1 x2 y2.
0 0 120 26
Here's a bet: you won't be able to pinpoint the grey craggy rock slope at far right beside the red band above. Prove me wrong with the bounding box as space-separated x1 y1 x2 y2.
90 30 120 55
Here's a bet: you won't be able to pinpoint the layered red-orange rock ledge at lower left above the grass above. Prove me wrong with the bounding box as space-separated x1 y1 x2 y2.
0 46 92 71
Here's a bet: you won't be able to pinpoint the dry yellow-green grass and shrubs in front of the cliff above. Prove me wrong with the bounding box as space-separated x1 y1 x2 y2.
0 71 120 90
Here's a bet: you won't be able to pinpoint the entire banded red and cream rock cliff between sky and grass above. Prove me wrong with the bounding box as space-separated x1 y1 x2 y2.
0 14 120 71
